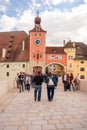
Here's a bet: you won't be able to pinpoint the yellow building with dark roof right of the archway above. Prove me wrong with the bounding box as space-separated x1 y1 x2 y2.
64 41 87 80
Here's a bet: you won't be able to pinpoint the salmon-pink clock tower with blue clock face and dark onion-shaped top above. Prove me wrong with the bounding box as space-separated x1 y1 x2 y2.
29 12 46 73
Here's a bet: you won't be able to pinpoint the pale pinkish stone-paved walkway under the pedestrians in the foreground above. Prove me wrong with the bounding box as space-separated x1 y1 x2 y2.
0 84 87 130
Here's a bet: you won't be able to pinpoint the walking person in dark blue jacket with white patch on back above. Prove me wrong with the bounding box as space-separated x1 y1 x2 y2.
46 72 57 101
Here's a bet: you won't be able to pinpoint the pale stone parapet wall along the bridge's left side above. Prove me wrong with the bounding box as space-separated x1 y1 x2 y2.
0 80 15 97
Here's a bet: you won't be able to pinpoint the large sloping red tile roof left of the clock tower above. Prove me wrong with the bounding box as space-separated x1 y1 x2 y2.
0 31 29 62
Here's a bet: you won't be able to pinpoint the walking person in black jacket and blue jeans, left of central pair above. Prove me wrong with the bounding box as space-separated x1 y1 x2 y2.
32 72 43 101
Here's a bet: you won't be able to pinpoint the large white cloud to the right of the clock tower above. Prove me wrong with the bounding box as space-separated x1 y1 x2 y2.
42 4 87 45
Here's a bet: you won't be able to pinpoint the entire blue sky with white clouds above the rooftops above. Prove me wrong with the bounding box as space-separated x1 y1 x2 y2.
0 0 87 46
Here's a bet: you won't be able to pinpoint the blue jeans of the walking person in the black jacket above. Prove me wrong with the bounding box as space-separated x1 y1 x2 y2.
34 85 42 101
